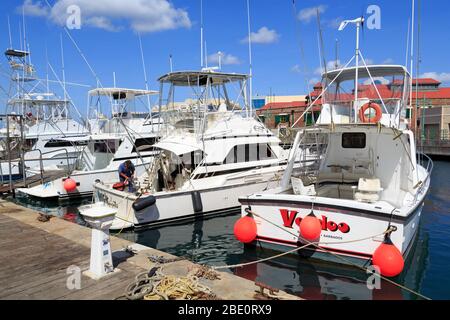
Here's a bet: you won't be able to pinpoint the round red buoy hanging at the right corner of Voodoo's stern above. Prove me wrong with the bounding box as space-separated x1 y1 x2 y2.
372 235 405 277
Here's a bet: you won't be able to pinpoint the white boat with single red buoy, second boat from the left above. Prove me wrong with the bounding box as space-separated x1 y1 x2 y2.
19 88 160 201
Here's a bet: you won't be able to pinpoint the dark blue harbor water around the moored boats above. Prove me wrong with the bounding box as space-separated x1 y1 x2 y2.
14 161 450 300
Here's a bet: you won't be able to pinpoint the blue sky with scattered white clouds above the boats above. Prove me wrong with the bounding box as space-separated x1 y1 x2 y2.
0 0 450 113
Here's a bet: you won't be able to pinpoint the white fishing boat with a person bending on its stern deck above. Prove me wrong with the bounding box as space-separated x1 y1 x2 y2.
85 70 310 229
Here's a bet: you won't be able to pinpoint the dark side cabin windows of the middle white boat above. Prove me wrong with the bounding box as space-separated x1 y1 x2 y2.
223 143 276 164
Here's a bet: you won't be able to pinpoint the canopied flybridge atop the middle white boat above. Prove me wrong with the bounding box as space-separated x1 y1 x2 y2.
159 71 250 136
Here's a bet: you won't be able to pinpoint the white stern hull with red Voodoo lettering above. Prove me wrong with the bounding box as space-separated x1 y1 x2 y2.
240 195 423 265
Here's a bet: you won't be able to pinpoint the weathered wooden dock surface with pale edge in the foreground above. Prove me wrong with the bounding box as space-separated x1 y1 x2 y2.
0 200 300 303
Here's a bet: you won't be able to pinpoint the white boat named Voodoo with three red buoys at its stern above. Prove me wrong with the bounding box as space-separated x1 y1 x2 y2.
235 18 433 276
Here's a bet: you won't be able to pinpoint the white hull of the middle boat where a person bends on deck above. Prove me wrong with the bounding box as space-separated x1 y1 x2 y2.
91 171 286 230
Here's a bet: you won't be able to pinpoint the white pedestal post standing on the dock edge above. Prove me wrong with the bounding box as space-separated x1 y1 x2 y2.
81 204 118 280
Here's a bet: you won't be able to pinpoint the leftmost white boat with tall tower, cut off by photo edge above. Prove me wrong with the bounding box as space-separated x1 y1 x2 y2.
0 49 89 182
